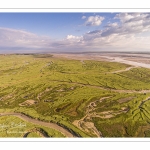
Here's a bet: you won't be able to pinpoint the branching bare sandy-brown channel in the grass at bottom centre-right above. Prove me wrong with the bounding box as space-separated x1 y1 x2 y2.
73 96 129 137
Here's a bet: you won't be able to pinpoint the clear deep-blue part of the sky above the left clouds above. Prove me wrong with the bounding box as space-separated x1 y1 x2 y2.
0 13 115 38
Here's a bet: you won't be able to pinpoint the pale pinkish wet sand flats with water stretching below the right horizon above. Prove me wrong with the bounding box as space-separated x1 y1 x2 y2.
53 53 150 69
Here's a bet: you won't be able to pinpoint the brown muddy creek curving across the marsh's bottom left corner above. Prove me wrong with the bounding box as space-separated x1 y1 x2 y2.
0 112 74 137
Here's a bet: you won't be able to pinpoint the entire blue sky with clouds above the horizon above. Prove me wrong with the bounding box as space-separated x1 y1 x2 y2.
0 12 150 53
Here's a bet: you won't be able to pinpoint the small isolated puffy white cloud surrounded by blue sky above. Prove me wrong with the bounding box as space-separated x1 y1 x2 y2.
85 15 105 26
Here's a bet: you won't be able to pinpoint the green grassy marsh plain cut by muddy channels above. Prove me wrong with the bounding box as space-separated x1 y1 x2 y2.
0 54 150 137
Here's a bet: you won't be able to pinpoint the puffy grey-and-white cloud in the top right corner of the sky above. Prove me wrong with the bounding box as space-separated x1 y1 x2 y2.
102 13 150 36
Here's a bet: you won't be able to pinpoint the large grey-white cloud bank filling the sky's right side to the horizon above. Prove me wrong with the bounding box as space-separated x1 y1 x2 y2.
73 13 150 50
